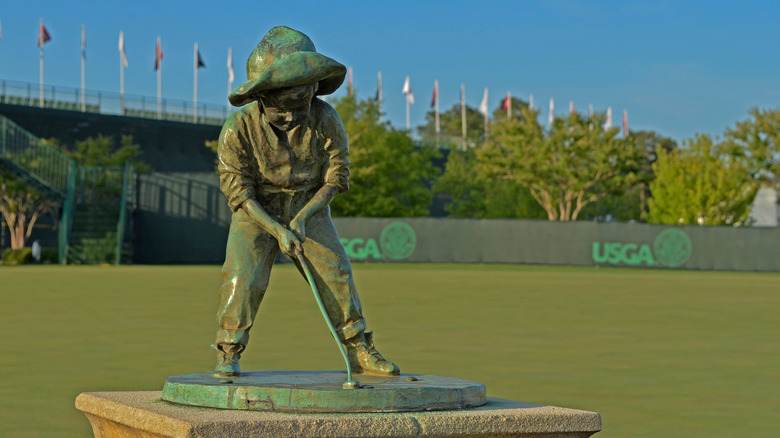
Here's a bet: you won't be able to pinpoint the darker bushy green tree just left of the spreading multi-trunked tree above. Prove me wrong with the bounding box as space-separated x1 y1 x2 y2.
434 148 546 218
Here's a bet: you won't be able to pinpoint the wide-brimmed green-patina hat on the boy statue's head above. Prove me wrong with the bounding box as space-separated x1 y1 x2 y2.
228 26 347 106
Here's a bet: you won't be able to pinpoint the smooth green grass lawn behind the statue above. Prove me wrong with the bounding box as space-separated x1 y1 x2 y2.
0 264 780 438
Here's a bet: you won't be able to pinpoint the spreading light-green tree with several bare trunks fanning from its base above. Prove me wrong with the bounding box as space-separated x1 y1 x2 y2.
477 107 641 221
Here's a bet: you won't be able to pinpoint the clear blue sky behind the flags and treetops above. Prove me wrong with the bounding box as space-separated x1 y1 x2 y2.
0 0 780 140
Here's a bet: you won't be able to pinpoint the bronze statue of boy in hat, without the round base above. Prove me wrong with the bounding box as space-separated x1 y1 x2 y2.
215 26 399 377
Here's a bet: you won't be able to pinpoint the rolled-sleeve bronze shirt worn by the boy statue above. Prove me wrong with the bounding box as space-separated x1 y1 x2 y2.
219 98 349 223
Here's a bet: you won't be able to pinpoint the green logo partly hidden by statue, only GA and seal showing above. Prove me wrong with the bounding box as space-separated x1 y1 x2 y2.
341 222 417 260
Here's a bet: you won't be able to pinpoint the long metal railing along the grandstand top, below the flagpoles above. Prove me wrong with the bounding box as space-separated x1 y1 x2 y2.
0 80 230 125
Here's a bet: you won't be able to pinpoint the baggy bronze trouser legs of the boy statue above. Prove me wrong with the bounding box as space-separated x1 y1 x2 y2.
216 208 366 345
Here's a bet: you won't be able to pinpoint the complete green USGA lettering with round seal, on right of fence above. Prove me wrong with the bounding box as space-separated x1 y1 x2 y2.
593 228 692 268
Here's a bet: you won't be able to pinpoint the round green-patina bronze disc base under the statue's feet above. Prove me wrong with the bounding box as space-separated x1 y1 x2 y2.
162 371 487 412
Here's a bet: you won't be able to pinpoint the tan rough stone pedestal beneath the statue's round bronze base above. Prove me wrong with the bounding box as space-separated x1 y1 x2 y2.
76 391 601 438
